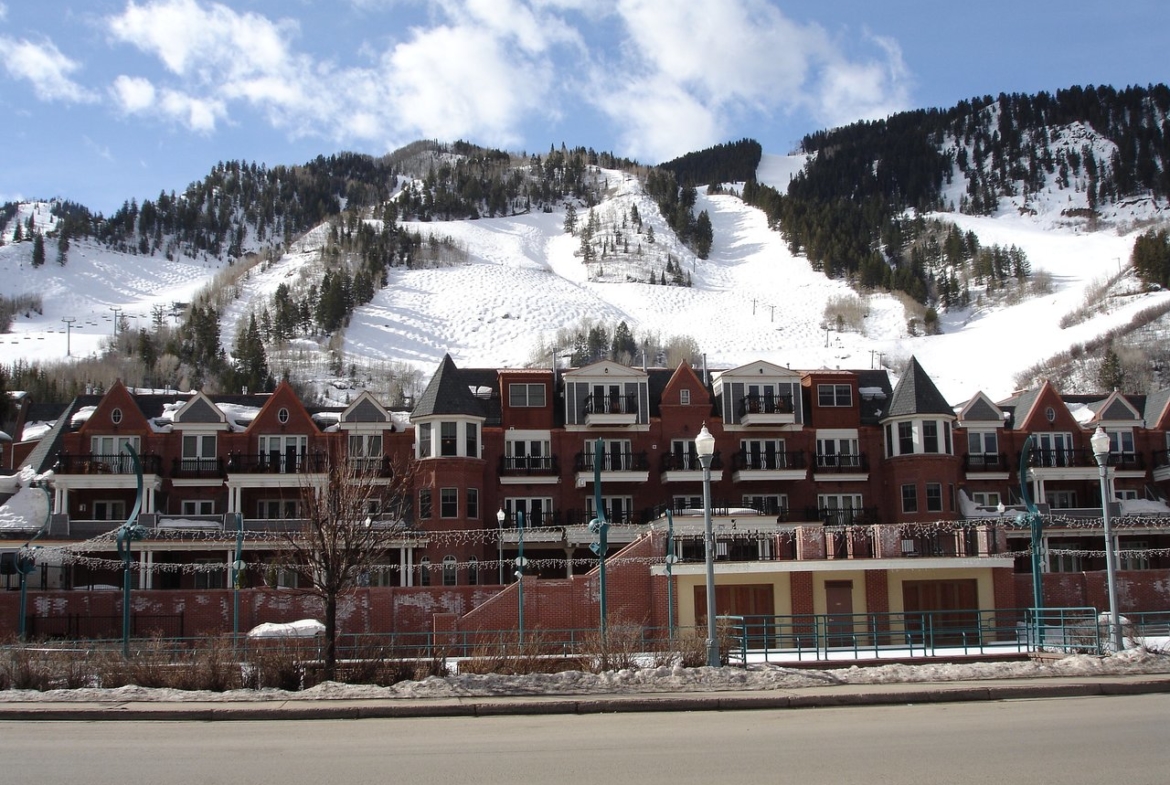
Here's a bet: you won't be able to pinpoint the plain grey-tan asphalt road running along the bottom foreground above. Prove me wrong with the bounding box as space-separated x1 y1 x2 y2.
0 694 1170 785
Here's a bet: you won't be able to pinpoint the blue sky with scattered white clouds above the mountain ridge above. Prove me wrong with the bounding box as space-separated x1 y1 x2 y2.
0 0 1170 213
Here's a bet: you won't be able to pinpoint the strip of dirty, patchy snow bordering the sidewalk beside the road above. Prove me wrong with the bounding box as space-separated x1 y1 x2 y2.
0 649 1170 703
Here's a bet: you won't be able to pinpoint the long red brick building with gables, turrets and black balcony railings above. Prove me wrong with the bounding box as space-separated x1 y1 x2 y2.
0 357 1170 634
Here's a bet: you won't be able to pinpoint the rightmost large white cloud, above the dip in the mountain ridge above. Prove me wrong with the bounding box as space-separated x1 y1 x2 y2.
591 0 908 160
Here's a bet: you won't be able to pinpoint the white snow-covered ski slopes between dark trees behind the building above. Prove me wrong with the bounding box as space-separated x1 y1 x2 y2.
0 149 1170 402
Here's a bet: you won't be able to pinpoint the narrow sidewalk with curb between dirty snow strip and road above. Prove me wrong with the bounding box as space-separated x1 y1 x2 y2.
0 674 1170 722
